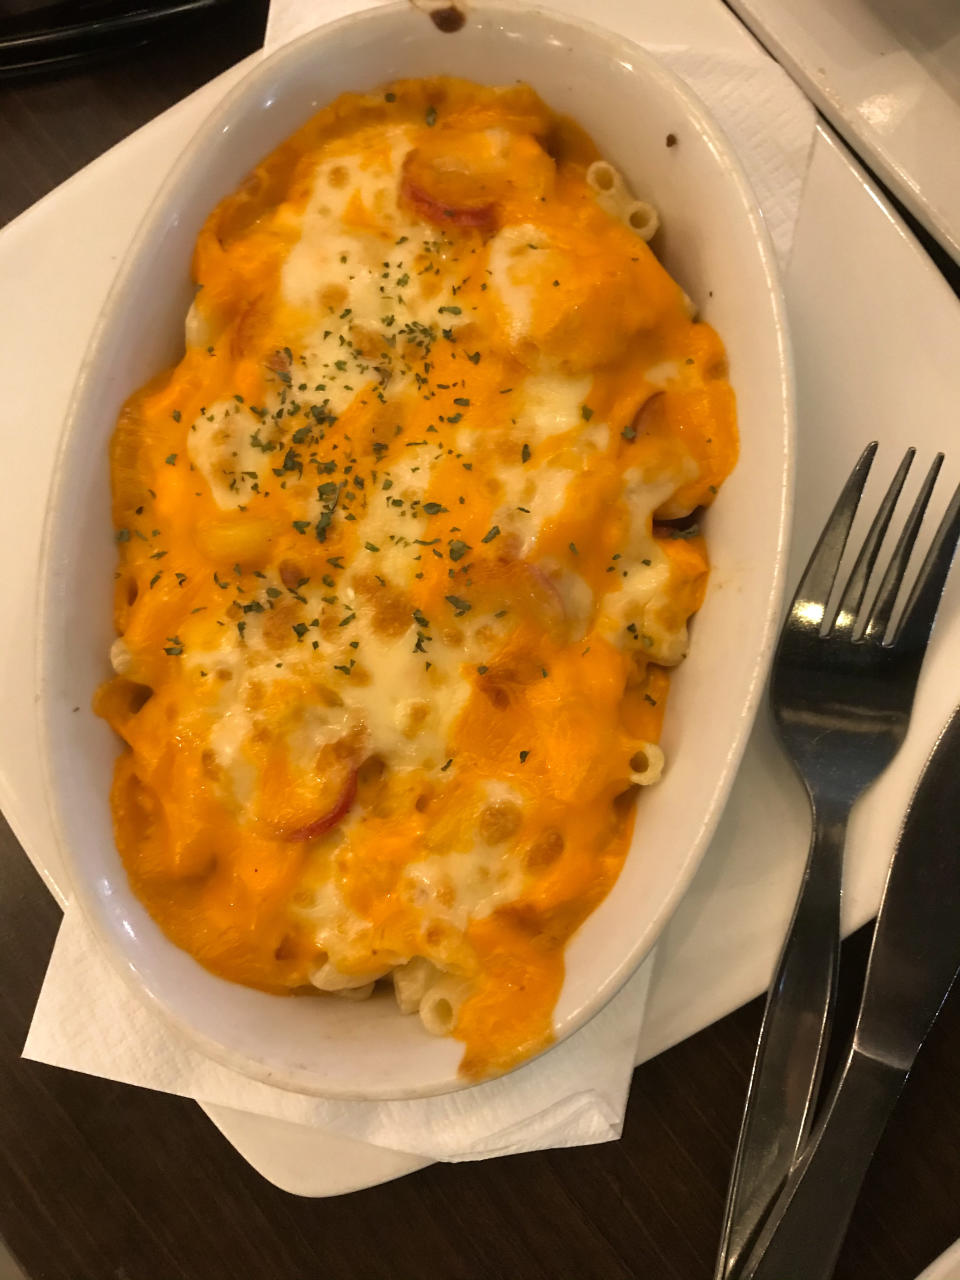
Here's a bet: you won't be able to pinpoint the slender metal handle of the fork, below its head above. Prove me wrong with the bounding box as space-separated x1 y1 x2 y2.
714 797 850 1280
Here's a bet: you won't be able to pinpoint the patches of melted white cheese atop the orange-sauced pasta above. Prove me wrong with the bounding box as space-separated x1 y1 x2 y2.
175 127 692 966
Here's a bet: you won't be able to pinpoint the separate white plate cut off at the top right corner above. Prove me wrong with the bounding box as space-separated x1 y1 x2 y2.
731 0 960 261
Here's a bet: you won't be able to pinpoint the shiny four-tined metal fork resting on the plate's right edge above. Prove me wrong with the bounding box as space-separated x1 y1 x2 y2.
714 442 960 1280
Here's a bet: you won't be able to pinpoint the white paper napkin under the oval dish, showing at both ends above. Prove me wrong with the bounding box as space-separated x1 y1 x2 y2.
24 0 815 1161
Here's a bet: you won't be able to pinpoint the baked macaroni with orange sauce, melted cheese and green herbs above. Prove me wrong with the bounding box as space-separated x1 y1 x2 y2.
96 78 737 1076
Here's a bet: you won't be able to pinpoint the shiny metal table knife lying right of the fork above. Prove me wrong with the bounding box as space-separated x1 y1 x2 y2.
741 708 960 1280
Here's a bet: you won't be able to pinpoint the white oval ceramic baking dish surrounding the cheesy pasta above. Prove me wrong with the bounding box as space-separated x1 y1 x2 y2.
38 4 792 1098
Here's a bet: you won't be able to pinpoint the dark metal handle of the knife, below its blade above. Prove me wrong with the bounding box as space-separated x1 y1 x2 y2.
744 1048 909 1280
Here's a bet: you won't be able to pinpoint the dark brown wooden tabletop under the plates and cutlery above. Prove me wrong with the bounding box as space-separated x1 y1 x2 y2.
0 0 960 1280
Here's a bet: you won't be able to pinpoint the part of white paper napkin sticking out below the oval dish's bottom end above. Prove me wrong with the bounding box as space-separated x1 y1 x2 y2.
23 908 653 1160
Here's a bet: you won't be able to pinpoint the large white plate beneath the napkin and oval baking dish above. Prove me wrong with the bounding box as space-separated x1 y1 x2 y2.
0 0 960 1203
